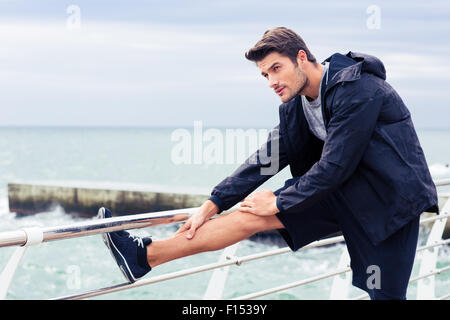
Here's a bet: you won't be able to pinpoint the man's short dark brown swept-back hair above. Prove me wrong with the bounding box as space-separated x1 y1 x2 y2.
245 27 316 65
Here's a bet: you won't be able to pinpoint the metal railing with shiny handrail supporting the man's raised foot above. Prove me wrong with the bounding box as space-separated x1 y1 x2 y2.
0 179 450 300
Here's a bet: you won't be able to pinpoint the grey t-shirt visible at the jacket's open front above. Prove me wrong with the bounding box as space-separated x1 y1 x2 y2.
301 63 328 141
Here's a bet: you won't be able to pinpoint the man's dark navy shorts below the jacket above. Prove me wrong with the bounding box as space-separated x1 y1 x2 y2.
274 188 419 300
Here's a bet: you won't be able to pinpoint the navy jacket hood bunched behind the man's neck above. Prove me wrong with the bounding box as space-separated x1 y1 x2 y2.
324 51 386 87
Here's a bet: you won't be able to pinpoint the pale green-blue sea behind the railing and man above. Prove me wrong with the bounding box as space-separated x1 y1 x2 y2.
0 127 450 300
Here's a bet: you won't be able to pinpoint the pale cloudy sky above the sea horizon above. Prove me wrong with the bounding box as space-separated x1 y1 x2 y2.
0 0 450 129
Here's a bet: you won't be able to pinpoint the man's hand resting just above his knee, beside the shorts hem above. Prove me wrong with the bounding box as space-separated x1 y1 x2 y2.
239 190 280 216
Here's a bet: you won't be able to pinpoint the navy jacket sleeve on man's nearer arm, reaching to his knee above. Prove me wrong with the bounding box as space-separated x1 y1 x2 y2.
277 84 383 211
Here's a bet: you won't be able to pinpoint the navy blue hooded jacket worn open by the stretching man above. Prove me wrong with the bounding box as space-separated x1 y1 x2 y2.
210 52 439 245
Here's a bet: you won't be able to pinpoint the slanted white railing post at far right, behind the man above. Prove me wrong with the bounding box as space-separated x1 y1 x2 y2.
417 198 450 300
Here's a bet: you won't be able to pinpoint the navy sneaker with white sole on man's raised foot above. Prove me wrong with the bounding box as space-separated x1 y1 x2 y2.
97 207 152 283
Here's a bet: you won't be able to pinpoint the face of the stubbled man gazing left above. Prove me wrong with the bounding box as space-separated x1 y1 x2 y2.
257 52 309 102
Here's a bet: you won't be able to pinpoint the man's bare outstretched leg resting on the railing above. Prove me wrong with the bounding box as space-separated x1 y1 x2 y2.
147 210 284 268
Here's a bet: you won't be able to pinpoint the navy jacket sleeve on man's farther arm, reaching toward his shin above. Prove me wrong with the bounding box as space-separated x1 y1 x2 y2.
209 125 288 212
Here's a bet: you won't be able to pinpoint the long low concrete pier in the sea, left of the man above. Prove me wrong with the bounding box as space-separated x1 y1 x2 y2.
8 183 209 217
